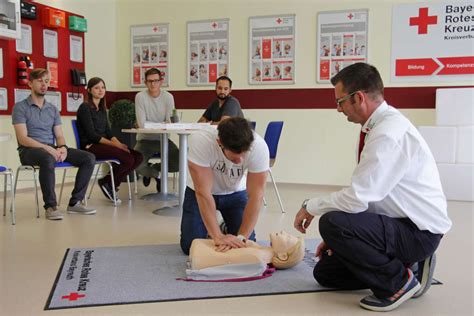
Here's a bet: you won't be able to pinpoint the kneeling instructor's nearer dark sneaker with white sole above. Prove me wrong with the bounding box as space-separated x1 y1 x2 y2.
359 269 420 312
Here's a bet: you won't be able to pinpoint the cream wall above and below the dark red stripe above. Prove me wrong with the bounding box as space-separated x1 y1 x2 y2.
0 0 472 185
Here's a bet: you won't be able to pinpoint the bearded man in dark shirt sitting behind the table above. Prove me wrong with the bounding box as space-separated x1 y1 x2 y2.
198 76 244 125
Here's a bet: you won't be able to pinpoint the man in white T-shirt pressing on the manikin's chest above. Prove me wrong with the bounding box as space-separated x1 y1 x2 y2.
181 117 270 254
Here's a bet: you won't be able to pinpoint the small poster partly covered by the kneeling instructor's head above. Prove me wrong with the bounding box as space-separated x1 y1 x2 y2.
316 10 369 82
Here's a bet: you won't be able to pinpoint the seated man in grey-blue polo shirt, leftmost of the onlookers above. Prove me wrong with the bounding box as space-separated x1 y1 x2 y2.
12 68 96 220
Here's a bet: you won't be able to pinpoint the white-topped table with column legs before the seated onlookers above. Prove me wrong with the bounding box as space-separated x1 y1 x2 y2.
122 128 199 214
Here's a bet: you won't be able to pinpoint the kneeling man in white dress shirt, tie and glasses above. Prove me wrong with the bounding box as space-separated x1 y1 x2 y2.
294 63 451 311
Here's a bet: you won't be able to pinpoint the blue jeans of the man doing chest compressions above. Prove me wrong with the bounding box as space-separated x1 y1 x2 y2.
180 187 255 255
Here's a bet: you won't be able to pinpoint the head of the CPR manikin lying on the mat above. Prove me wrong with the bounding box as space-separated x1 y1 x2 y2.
270 231 304 269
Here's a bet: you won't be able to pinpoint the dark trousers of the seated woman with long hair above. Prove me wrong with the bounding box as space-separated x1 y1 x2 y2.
87 144 143 189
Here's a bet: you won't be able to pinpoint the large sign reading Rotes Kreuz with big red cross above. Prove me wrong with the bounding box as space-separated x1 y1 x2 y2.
391 0 474 82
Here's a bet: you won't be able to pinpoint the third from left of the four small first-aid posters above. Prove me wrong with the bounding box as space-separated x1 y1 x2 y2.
249 14 296 84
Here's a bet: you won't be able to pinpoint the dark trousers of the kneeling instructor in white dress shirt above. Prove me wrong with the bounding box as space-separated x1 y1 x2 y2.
314 211 442 298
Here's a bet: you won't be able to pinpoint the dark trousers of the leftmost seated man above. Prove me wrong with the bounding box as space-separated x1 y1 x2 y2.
20 147 95 209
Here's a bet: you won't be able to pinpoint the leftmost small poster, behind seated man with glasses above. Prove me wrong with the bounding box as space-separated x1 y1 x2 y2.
130 23 169 87
